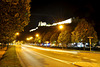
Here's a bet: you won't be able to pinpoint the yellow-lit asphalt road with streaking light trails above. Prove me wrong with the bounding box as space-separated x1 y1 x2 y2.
16 45 100 67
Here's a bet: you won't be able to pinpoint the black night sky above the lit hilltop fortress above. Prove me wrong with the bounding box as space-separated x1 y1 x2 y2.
25 0 100 34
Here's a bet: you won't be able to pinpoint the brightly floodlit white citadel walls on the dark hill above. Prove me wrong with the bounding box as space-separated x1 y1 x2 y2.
29 18 72 32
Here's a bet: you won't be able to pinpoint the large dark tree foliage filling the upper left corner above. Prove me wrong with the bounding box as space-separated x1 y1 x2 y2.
0 0 30 42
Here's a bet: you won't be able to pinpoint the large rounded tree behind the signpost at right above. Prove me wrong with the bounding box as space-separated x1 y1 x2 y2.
71 19 98 43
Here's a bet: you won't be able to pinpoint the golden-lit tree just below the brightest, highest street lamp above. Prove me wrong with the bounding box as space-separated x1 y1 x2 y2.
57 24 73 47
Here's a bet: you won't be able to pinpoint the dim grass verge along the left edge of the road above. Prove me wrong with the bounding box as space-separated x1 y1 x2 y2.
0 46 22 67
